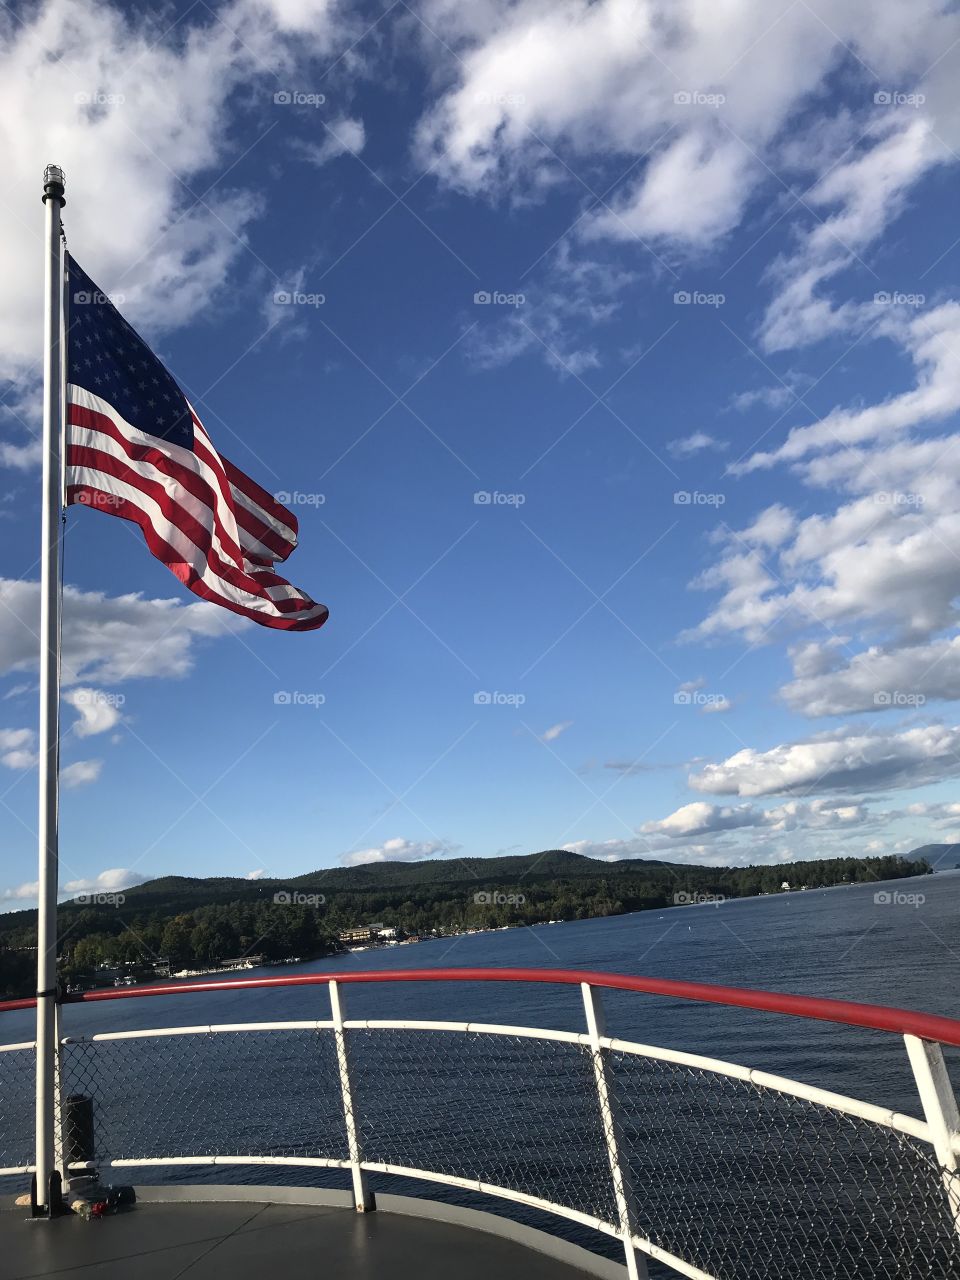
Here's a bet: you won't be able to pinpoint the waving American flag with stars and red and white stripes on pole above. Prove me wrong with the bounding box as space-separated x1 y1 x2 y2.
67 257 328 631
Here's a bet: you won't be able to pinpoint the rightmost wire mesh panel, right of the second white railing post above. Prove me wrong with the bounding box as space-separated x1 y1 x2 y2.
605 1051 960 1280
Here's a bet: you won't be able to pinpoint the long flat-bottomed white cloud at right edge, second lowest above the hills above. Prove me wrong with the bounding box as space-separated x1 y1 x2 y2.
689 724 960 796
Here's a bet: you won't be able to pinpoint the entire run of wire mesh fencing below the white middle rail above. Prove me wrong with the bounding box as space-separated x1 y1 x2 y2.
7 1024 960 1280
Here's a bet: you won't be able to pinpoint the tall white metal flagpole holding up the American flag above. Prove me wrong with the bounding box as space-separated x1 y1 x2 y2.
32 165 65 1215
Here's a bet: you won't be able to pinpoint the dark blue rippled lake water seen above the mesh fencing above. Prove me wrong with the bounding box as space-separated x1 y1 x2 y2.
0 872 960 1269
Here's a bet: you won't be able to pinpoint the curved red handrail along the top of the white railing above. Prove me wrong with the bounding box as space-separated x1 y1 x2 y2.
0 969 960 1046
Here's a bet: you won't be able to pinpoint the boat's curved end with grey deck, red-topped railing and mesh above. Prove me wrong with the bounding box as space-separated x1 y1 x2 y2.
0 968 960 1280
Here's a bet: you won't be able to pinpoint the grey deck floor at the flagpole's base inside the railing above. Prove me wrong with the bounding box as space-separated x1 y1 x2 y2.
0 1203 611 1280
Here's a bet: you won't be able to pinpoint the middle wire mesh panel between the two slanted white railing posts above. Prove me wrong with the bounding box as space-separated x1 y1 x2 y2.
347 1029 617 1224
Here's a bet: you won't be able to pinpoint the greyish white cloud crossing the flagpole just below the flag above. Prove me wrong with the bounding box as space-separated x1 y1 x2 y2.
0 579 244 685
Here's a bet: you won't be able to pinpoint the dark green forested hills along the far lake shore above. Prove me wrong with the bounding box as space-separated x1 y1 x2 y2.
0 849 936 995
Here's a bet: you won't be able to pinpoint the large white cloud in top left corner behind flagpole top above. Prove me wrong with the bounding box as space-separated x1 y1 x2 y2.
0 0 353 466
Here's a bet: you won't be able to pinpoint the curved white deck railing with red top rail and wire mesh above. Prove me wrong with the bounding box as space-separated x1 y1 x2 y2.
0 969 960 1280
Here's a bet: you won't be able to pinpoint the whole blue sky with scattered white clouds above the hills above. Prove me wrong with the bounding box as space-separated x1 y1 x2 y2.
0 0 960 909
